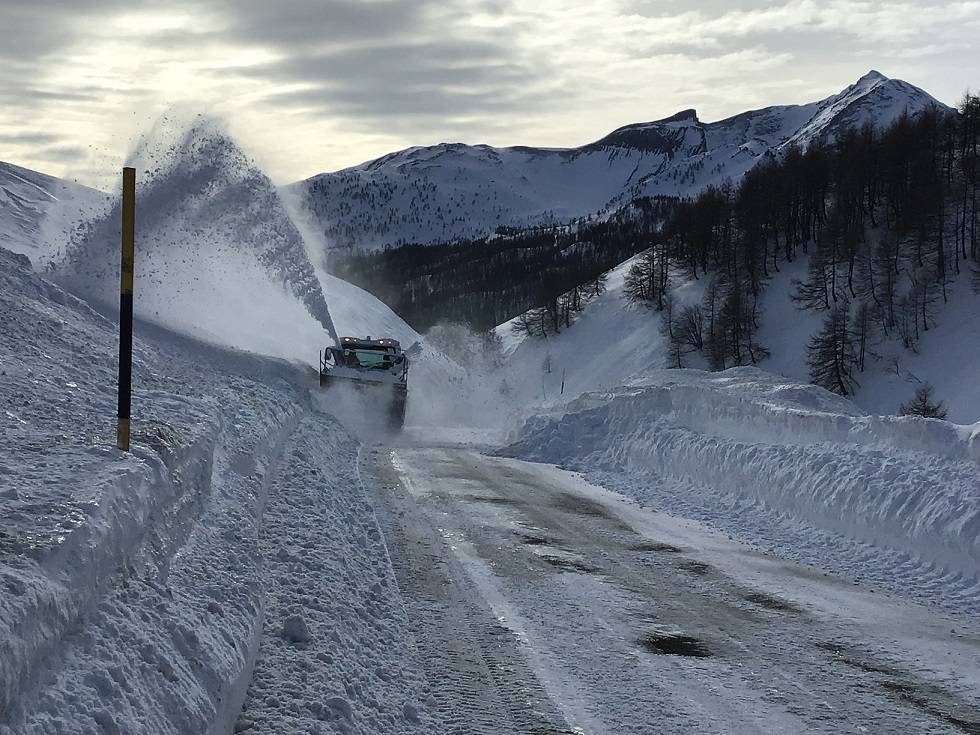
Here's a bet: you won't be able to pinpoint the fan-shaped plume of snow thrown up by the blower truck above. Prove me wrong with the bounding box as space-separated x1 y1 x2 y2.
57 115 335 362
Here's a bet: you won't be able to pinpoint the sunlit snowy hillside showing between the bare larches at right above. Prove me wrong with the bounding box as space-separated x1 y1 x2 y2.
497 249 980 425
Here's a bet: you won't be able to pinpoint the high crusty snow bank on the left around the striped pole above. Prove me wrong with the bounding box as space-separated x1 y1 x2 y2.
0 250 296 733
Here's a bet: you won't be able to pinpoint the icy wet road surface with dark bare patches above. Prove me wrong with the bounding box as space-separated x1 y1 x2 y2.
361 446 980 735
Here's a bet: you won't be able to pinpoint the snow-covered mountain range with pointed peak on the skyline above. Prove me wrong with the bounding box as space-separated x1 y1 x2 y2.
288 71 943 249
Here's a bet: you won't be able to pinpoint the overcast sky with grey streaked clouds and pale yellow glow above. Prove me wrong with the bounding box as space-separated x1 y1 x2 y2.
0 0 980 187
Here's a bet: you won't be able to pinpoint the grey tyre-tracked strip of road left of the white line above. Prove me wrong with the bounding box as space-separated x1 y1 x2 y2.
361 449 580 735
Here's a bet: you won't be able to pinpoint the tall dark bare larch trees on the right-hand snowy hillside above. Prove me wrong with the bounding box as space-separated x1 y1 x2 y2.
626 95 980 395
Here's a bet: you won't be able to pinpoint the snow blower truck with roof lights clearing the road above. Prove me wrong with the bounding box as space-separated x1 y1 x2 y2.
320 336 408 431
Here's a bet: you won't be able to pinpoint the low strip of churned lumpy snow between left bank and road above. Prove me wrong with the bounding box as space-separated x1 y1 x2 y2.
234 414 433 735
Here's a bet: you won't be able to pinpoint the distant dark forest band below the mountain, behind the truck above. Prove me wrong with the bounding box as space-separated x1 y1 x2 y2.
330 197 675 332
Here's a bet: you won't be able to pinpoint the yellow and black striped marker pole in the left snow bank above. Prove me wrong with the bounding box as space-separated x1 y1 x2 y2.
116 168 136 452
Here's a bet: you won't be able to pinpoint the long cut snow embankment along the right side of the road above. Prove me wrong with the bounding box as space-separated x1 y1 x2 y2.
505 368 980 610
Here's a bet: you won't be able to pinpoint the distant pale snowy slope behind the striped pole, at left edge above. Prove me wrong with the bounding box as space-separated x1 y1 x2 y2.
0 161 109 265
